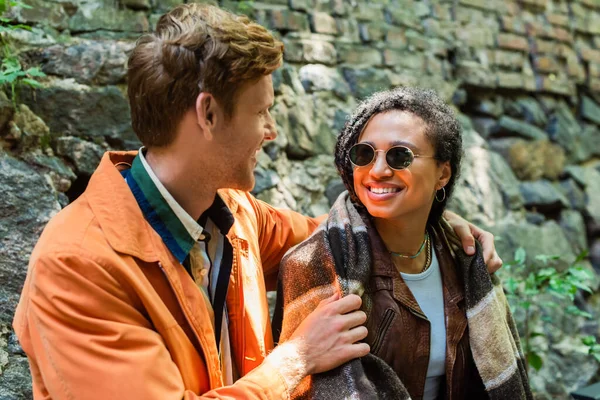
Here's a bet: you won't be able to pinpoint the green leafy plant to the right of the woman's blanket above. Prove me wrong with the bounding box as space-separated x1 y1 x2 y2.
503 247 600 371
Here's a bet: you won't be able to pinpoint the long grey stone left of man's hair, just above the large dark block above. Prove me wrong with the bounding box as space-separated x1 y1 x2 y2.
39 40 134 85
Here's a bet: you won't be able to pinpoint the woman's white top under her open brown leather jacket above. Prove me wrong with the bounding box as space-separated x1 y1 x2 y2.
400 247 446 400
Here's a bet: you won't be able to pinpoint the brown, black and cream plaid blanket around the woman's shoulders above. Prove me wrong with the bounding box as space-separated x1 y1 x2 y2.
274 192 533 400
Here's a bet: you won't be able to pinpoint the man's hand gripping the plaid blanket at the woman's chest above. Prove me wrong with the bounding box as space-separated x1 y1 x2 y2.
290 294 370 375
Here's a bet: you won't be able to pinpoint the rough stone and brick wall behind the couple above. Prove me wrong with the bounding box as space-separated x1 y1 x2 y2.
0 0 600 399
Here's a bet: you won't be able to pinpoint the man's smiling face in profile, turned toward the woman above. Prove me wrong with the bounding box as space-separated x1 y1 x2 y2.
217 75 277 190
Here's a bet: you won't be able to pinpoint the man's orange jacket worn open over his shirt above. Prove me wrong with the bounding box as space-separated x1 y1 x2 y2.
14 152 318 400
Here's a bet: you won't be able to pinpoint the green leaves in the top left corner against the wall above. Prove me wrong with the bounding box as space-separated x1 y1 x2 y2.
0 0 46 106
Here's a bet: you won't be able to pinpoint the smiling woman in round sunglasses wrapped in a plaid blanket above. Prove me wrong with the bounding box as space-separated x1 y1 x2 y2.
279 88 531 400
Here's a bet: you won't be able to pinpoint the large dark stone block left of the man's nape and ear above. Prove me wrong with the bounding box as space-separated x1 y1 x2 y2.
22 80 139 149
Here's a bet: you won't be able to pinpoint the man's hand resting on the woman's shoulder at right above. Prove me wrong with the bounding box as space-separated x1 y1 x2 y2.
444 211 502 274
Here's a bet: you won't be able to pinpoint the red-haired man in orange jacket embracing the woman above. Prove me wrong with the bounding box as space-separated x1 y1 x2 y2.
14 4 500 400
